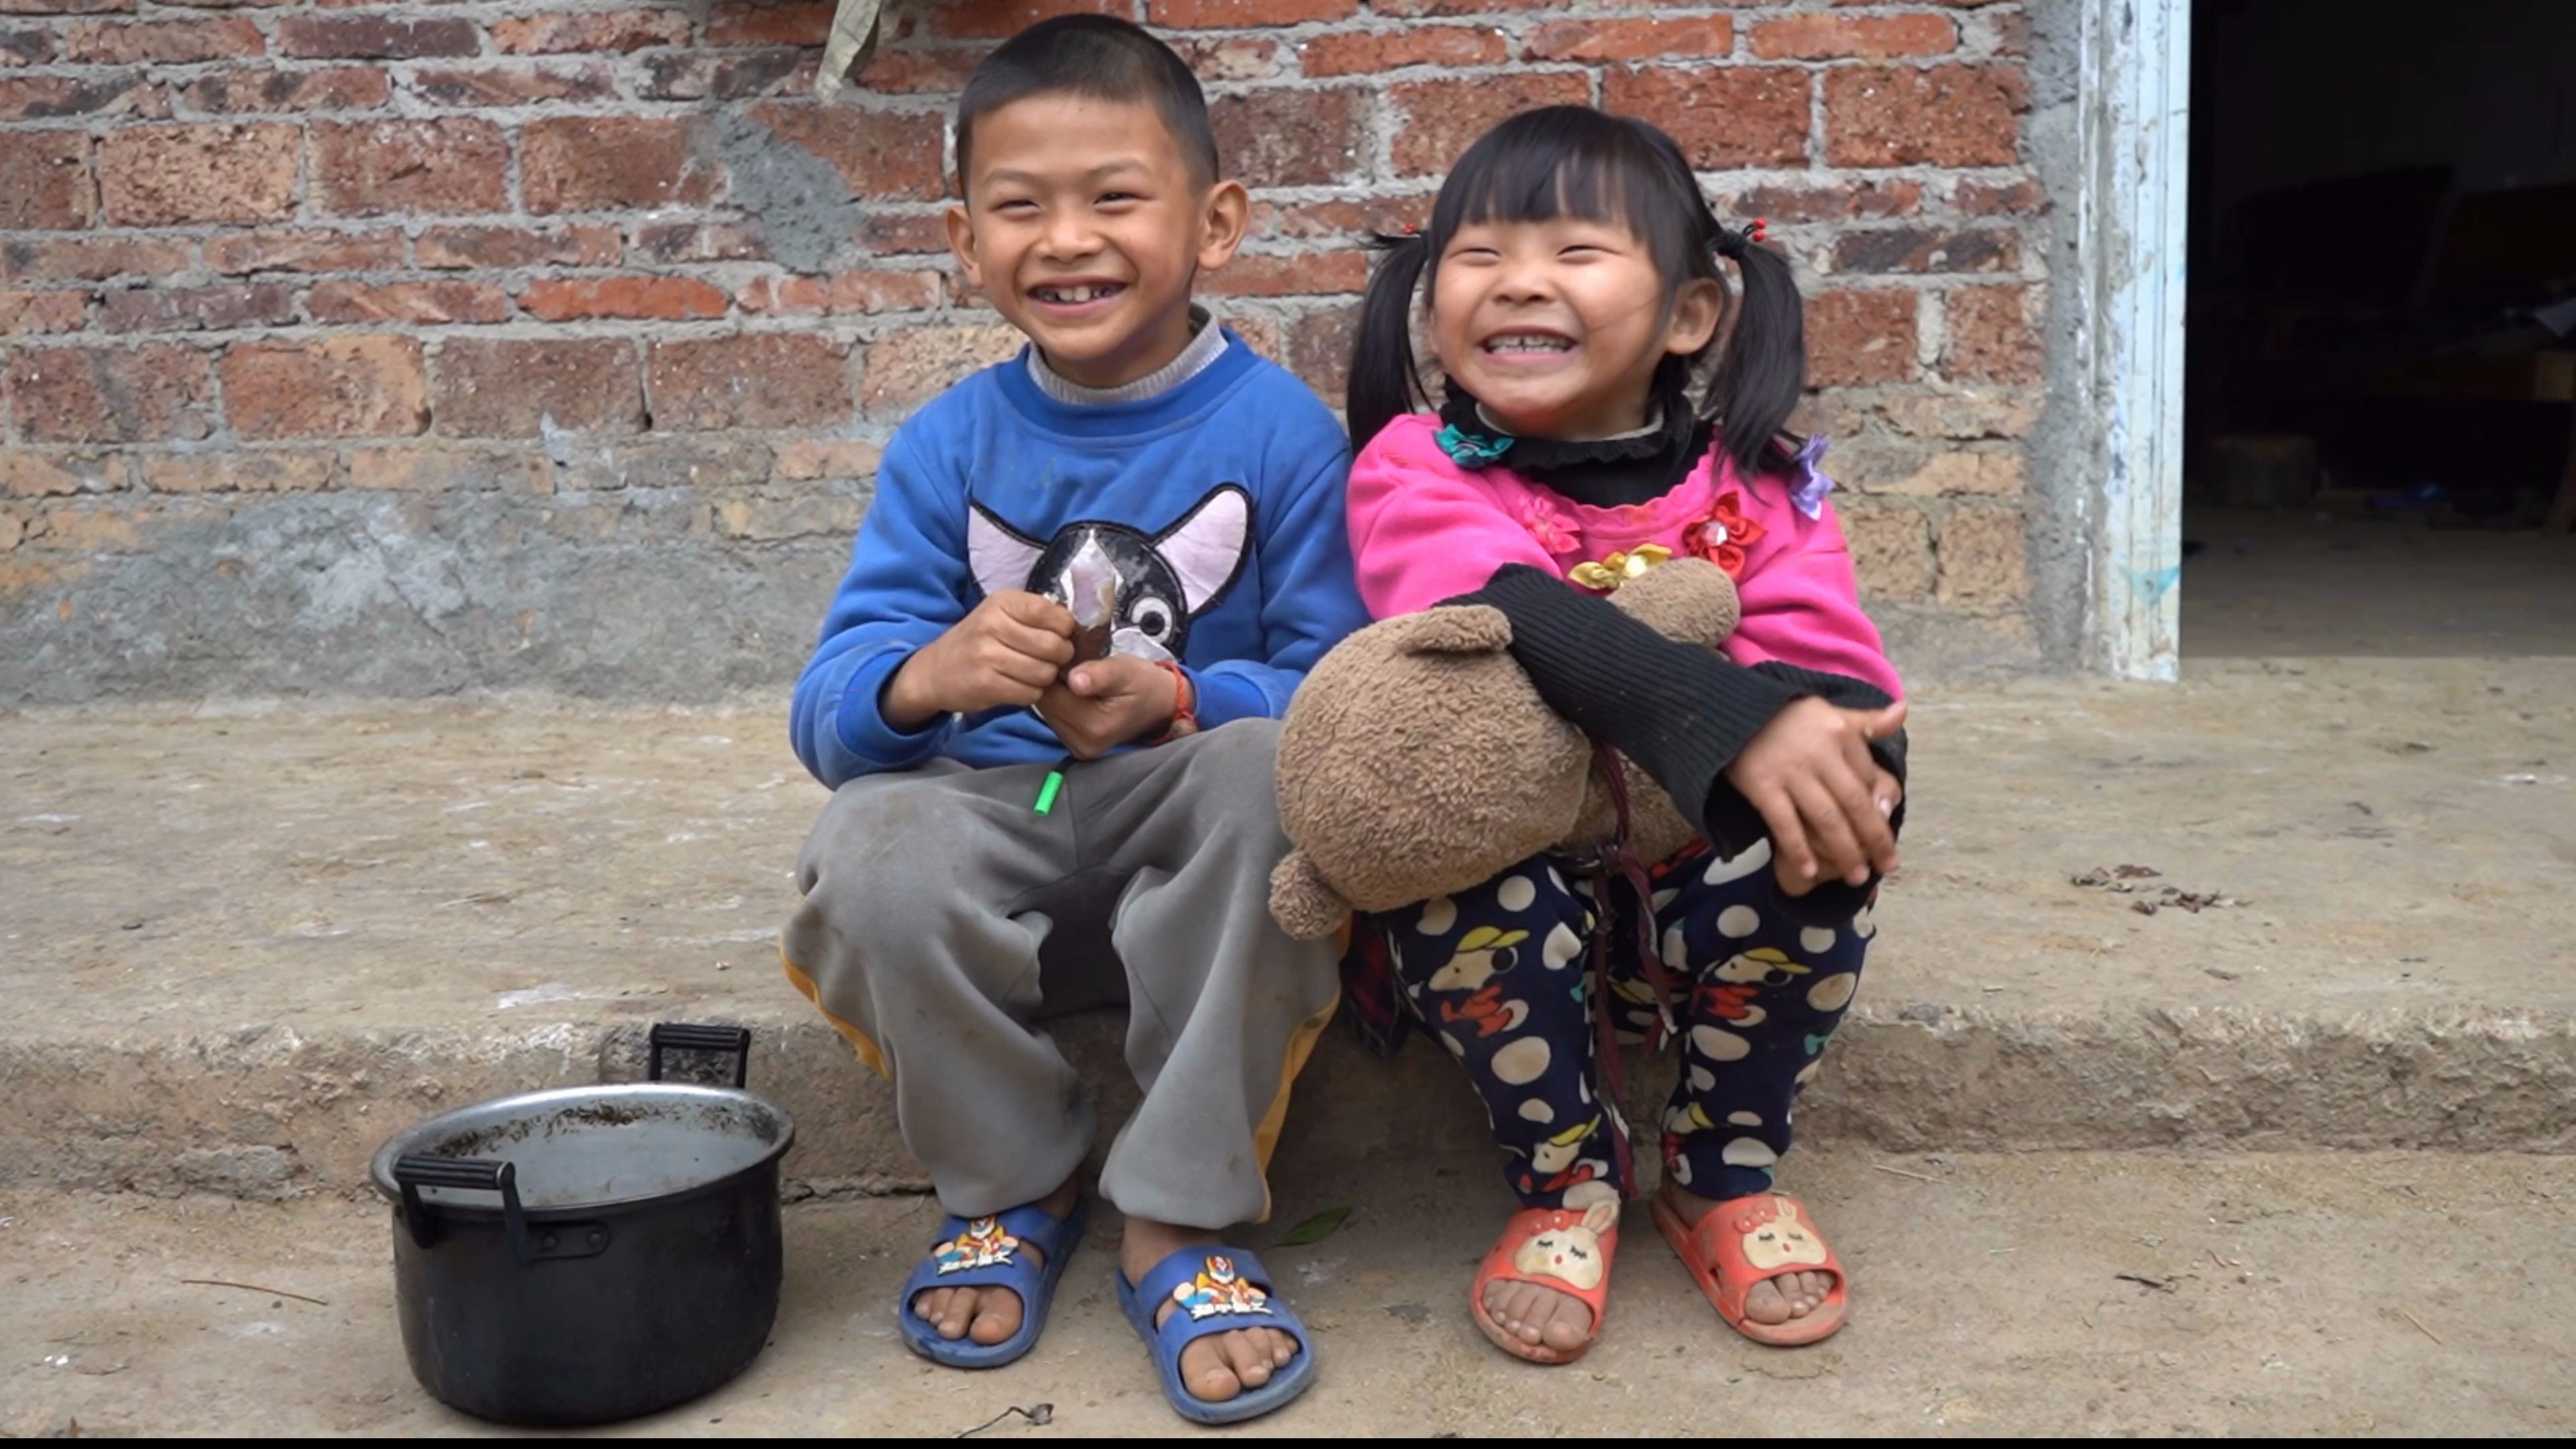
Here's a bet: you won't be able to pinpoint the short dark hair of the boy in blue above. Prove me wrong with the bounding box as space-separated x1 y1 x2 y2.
958 15 1216 186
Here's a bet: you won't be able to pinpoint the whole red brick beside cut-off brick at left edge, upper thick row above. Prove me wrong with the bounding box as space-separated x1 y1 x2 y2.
98 123 297 227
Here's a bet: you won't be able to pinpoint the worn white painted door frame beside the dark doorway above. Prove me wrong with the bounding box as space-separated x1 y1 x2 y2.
2061 0 2192 681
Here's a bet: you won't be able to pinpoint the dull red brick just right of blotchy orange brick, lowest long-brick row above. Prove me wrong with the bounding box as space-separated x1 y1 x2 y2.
433 337 644 438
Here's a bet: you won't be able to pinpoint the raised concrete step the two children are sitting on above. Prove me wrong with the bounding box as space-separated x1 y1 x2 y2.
0 660 2576 1196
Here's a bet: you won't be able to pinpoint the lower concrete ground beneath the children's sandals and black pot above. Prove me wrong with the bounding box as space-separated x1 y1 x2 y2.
0 1147 2576 1441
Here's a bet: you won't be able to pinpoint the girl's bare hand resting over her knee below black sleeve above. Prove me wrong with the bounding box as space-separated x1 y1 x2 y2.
1726 699 1907 895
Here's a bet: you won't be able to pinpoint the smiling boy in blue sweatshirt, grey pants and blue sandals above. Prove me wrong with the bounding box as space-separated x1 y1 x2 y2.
783 15 1365 1424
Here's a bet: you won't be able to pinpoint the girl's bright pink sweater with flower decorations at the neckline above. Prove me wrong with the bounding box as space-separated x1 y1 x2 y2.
1350 413 1904 699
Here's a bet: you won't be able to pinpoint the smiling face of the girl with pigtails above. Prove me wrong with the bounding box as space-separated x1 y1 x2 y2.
1432 214 1723 441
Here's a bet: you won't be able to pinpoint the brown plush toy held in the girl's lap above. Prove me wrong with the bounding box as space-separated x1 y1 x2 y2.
1270 559 1739 938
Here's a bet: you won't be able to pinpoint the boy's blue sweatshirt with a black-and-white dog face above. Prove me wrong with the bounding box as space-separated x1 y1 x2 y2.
788 333 1368 789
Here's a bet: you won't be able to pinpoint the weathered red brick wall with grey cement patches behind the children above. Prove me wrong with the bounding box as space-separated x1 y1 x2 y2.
0 0 2045 701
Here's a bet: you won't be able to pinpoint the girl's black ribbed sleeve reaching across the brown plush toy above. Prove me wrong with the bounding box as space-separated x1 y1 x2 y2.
1450 565 1907 926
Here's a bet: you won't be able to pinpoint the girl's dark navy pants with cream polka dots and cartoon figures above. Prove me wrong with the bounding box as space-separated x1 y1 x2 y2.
1389 841 1873 1207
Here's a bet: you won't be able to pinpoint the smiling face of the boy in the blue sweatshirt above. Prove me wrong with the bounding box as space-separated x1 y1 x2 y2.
948 93 1252 387
